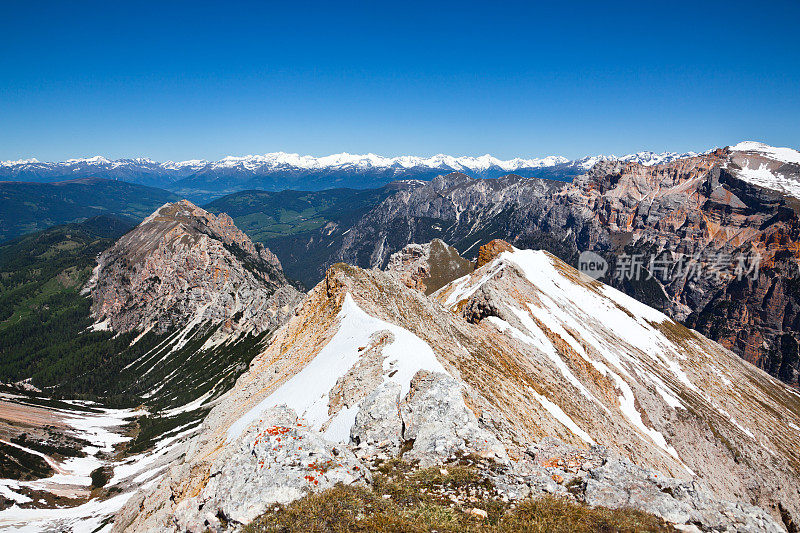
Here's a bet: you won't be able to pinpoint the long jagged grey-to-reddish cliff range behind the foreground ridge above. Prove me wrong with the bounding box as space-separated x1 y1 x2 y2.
296 149 800 385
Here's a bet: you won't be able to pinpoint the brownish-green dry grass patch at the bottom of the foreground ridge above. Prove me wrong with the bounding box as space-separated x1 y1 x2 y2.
244 461 674 533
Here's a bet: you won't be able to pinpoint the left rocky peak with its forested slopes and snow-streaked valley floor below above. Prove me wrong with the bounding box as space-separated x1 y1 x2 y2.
0 201 300 530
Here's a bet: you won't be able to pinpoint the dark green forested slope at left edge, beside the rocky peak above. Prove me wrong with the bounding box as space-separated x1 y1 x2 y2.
0 216 137 387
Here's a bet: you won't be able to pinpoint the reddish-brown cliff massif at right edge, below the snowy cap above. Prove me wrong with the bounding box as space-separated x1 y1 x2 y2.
536 151 800 385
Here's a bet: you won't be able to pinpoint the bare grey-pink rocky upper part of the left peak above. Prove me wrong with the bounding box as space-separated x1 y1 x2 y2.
91 200 299 333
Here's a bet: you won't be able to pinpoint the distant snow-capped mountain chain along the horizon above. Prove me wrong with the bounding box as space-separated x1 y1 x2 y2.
0 148 708 198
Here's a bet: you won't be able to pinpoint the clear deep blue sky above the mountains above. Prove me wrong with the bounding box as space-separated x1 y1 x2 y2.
0 0 800 160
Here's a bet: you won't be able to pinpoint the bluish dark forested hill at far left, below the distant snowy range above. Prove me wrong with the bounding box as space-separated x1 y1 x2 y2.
0 178 178 241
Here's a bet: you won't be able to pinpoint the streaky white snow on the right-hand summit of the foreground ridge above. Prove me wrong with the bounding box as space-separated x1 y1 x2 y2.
442 249 708 473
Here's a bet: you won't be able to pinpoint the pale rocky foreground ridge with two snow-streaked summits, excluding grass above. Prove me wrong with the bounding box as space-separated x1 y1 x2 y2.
115 246 800 531
